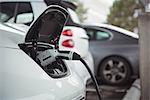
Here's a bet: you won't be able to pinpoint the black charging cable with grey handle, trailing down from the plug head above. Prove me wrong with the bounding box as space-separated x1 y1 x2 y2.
57 51 102 100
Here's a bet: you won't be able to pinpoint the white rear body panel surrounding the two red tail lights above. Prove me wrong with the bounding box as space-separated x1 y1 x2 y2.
59 26 89 58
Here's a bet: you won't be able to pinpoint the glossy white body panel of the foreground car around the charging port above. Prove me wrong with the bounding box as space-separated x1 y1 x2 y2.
0 5 85 100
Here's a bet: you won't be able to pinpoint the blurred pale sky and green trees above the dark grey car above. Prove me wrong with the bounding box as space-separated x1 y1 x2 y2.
74 0 144 33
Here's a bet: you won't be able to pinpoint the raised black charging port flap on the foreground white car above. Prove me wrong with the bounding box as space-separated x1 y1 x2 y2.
25 5 68 45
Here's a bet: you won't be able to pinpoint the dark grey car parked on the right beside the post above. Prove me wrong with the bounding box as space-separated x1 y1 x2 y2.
84 23 139 85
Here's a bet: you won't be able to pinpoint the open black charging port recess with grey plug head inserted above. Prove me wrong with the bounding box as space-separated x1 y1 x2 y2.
19 43 69 78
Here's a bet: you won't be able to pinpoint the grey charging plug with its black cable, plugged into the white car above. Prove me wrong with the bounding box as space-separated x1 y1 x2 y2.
37 49 101 100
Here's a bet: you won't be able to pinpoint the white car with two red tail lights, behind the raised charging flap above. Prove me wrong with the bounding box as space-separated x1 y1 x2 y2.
0 0 94 84
